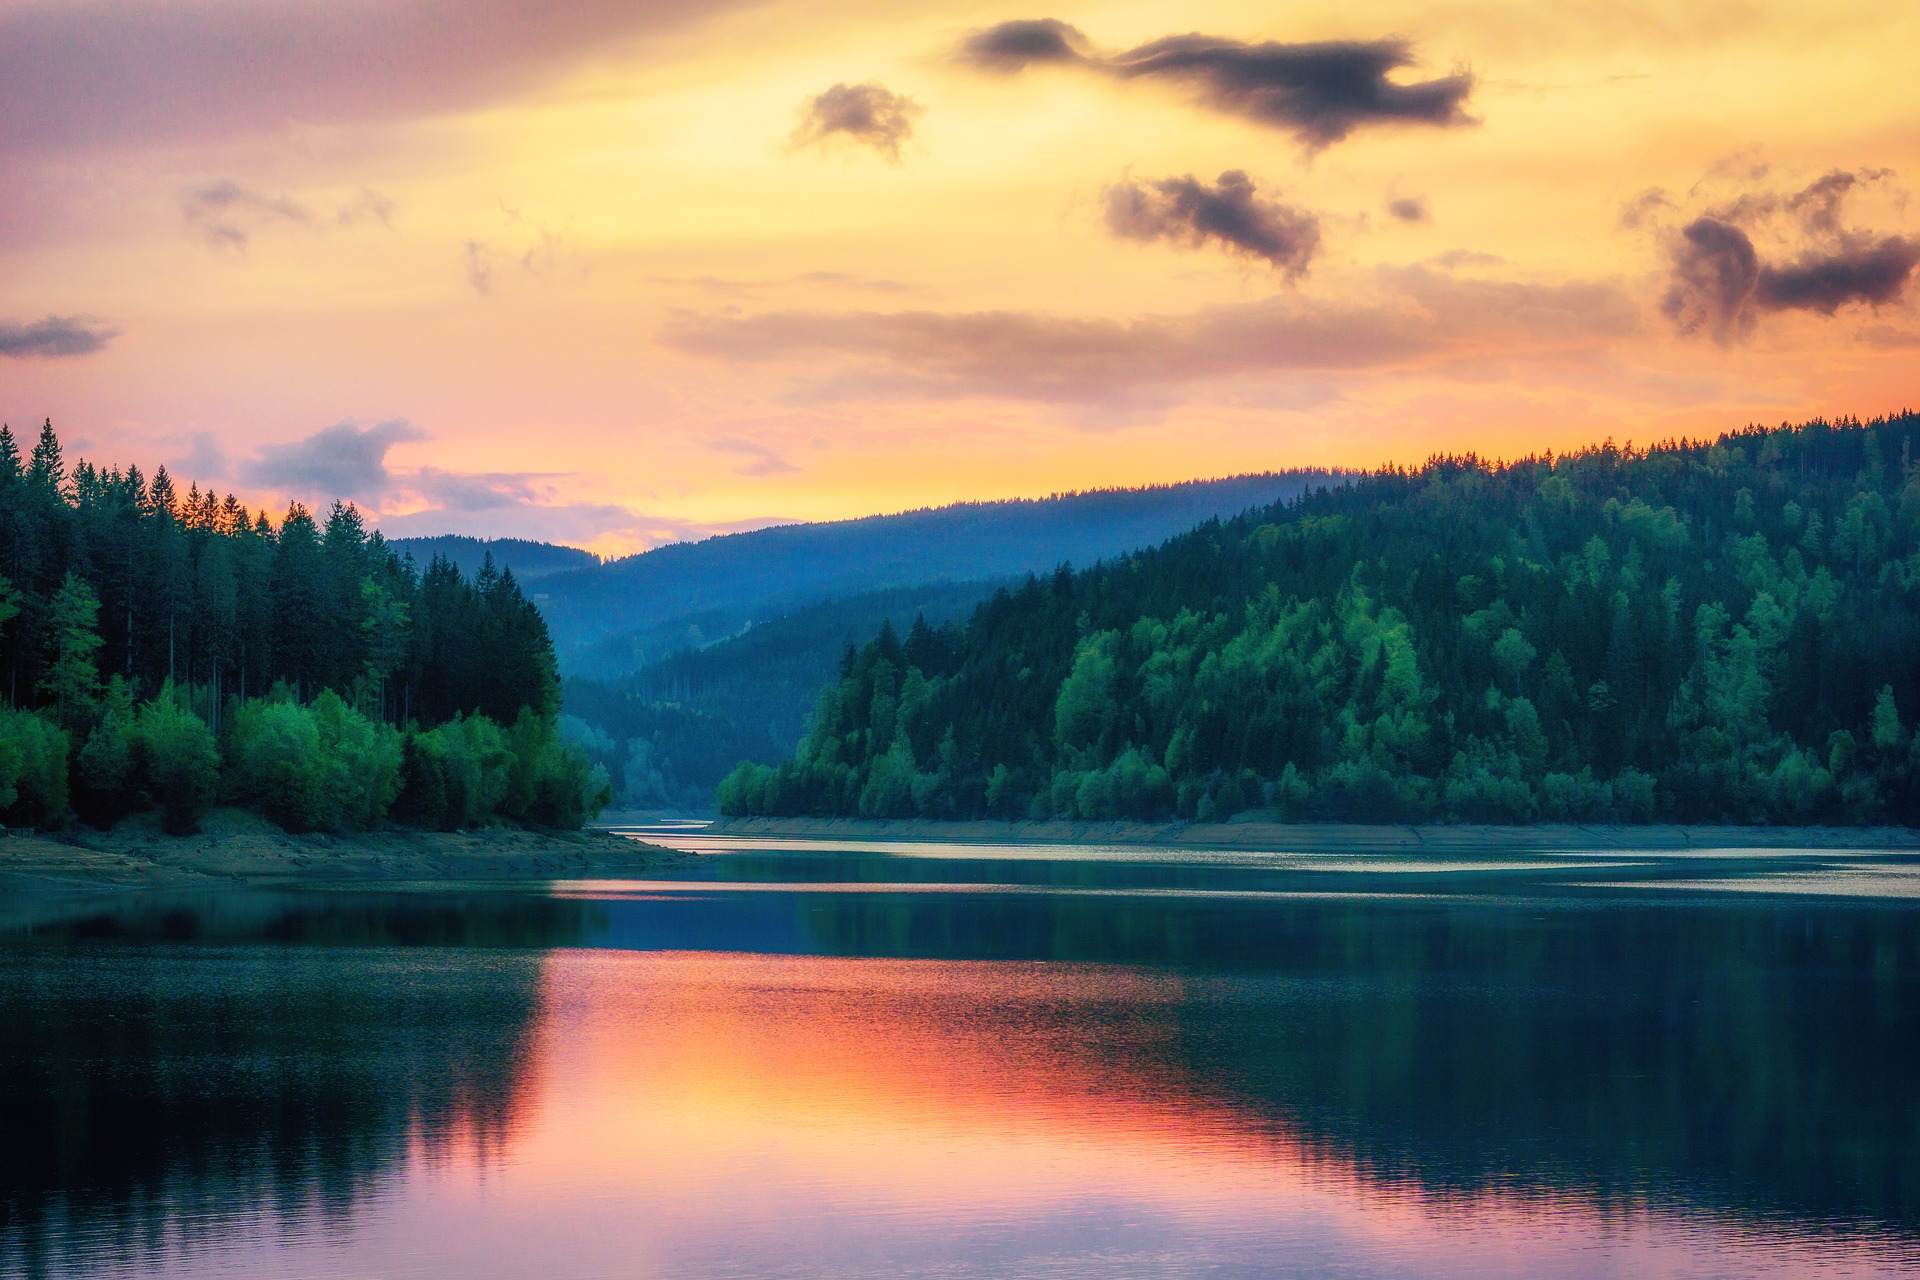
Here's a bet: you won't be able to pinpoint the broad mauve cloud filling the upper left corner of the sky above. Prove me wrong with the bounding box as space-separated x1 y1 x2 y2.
0 0 756 154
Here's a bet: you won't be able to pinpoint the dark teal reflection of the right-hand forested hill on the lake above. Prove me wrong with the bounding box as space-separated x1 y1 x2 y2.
791 885 1920 1232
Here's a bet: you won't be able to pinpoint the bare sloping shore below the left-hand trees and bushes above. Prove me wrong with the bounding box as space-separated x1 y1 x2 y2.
0 810 691 898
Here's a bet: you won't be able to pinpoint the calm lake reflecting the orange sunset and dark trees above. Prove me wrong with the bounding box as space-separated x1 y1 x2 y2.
0 829 1920 1280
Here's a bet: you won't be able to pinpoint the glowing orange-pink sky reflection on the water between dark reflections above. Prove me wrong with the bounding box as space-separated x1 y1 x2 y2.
393 950 1884 1274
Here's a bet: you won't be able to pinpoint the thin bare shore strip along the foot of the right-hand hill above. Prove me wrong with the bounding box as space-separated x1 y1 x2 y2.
707 818 1920 854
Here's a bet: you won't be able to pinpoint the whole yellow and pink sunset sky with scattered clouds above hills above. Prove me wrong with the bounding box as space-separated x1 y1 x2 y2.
0 0 1920 553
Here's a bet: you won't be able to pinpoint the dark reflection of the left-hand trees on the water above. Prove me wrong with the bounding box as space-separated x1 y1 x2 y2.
0 894 593 1276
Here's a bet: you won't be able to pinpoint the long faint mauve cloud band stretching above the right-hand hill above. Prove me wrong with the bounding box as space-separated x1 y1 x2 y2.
659 267 1638 405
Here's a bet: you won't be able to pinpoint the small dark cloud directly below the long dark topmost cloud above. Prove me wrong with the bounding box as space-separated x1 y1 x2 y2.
1106 169 1319 280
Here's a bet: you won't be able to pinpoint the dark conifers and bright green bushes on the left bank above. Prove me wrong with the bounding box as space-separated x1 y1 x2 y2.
0 422 607 829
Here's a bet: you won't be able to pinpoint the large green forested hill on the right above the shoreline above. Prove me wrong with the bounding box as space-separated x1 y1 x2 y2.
718 413 1920 823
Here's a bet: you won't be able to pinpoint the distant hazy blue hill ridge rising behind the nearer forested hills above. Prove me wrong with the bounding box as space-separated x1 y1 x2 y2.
540 470 1338 660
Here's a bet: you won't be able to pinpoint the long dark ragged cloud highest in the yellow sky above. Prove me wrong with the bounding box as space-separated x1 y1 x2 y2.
960 19 1473 150
